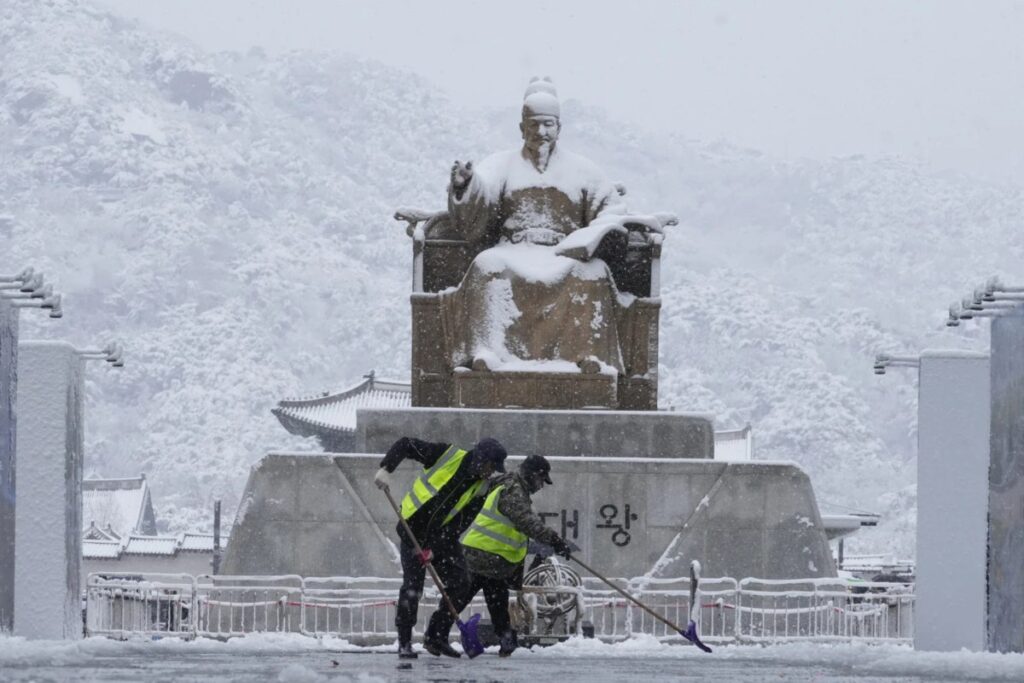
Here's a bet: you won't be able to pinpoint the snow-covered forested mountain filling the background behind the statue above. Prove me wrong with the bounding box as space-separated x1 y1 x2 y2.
0 0 1024 555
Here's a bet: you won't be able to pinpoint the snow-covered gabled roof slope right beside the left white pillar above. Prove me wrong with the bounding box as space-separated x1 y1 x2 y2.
82 474 157 537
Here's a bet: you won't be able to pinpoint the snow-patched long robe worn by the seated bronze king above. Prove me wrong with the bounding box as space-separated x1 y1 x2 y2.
440 147 633 373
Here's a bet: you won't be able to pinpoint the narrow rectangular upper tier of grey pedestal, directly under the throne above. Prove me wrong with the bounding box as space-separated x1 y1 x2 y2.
355 408 715 460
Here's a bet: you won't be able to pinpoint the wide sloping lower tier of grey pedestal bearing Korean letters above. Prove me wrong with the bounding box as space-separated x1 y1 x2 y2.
221 454 836 579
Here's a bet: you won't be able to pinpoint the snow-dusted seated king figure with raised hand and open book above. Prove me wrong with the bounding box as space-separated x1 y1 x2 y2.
397 78 675 409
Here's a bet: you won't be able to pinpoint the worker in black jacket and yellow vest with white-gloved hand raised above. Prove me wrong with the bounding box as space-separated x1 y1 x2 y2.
374 436 508 659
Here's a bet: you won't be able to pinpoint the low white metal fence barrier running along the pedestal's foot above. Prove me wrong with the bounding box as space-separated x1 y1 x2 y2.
86 573 913 644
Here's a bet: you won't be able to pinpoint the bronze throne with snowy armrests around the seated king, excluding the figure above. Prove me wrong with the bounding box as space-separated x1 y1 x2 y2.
395 206 663 411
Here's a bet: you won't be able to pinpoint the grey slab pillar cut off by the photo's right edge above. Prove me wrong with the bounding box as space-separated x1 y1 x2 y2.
983 309 1024 652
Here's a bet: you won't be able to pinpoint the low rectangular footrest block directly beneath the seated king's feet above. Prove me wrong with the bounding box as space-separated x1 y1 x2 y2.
453 370 618 410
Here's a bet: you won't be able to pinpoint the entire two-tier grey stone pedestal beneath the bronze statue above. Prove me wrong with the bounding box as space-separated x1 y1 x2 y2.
222 408 836 579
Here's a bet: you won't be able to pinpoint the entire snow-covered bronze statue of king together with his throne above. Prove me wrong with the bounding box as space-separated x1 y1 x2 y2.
396 79 675 410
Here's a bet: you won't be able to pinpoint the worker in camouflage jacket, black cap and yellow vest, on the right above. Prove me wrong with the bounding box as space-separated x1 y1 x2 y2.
425 456 572 656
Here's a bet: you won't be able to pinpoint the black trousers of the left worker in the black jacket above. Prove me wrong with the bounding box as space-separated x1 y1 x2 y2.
394 537 472 643
